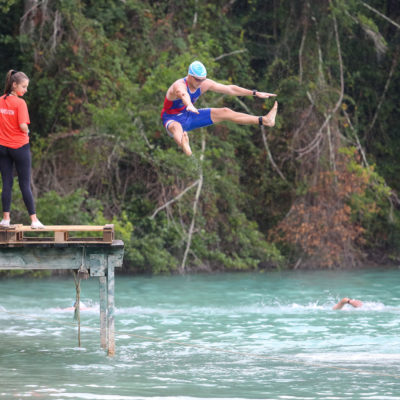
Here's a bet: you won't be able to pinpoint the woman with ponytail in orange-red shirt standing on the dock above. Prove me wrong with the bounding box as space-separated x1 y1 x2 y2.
0 69 44 229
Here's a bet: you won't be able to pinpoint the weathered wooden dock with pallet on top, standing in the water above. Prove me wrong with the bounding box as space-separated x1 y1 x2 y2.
0 225 124 356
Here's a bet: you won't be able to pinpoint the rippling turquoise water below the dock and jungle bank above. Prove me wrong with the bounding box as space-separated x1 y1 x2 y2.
0 269 400 400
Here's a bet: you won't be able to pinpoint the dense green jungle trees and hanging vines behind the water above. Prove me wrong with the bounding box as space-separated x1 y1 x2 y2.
0 0 400 274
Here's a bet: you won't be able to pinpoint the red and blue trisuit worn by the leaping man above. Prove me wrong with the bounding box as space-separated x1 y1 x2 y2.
161 78 214 136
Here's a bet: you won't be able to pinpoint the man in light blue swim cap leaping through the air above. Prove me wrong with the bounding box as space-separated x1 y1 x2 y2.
161 61 278 156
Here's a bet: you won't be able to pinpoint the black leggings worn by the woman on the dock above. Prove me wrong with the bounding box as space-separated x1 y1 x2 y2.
0 143 36 215
